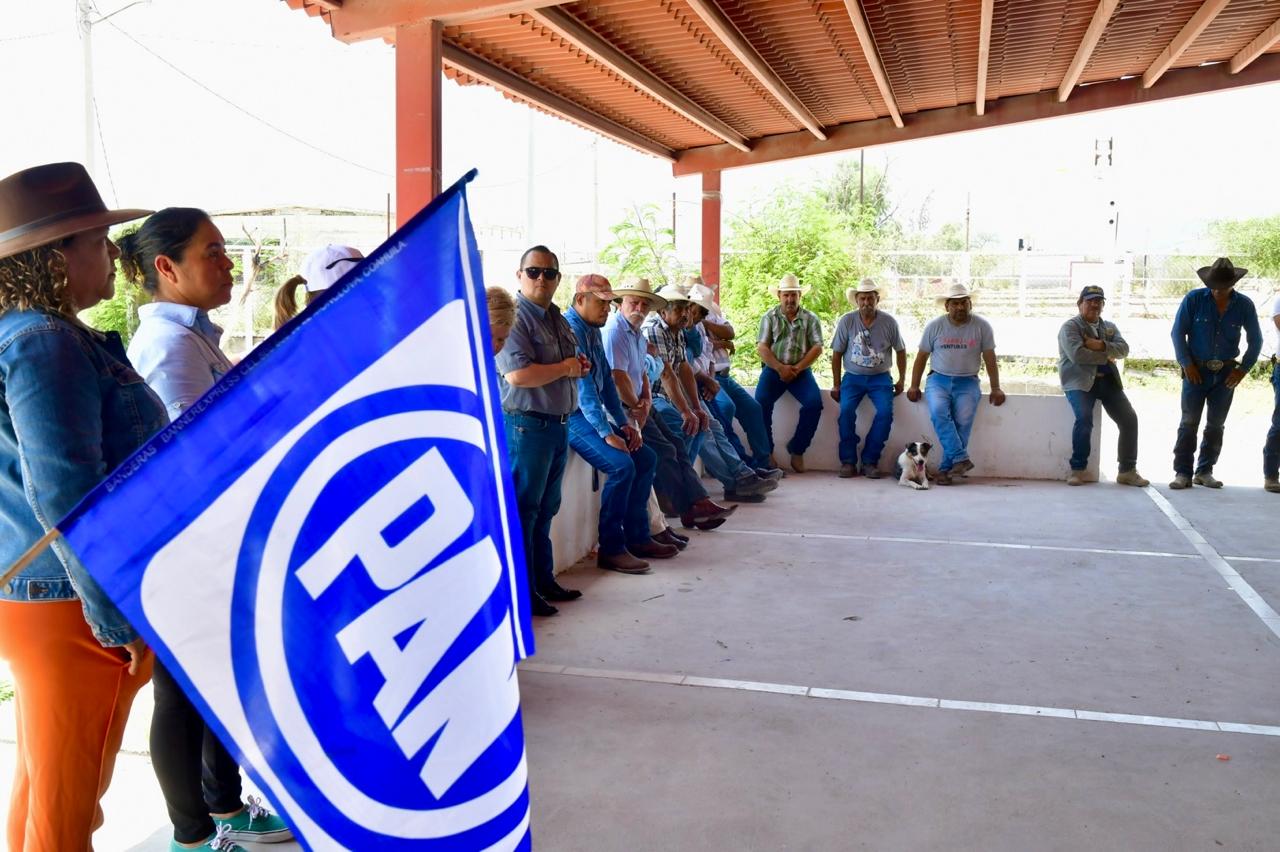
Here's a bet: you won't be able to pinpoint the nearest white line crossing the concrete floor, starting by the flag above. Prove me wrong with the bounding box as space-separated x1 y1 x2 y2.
520 660 1280 737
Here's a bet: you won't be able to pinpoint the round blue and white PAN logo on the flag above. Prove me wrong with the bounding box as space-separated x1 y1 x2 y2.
233 386 527 848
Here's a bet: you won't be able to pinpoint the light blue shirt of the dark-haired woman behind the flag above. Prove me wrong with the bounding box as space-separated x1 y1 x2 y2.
129 302 232 418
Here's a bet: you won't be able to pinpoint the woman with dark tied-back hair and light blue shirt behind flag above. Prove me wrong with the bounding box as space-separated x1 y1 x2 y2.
120 207 293 852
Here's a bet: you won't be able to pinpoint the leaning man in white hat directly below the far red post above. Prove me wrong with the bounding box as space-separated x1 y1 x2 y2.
685 275 777 476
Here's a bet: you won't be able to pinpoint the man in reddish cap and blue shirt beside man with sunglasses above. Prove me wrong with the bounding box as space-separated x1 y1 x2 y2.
564 275 680 574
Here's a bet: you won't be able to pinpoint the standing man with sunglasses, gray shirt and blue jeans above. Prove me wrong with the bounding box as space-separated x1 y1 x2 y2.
497 246 590 615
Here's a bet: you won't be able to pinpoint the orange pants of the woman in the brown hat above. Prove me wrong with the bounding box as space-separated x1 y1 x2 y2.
0 600 154 852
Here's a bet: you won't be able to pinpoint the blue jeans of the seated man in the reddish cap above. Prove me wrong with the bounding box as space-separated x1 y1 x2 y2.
568 412 658 556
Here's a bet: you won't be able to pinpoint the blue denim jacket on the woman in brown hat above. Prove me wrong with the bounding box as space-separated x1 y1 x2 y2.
0 311 168 646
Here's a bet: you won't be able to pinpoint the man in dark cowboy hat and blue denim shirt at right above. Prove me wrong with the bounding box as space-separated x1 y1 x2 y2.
1169 257 1262 489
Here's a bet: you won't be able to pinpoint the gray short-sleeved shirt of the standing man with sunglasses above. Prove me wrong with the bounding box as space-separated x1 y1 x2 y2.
498 293 577 416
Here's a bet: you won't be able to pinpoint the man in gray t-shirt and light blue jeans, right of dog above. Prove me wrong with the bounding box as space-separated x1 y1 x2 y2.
906 284 1005 485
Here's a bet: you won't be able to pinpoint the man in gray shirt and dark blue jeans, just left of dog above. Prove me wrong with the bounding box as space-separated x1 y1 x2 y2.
831 278 906 480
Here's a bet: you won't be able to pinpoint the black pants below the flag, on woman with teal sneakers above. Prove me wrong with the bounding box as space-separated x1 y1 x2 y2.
151 660 244 843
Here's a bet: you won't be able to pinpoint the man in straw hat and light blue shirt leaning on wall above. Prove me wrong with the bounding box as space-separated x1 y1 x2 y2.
602 278 733 532
